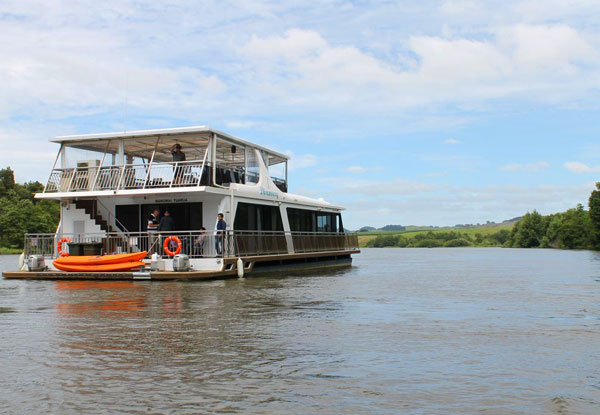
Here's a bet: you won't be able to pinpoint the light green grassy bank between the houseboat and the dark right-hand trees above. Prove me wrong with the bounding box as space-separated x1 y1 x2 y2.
358 224 513 248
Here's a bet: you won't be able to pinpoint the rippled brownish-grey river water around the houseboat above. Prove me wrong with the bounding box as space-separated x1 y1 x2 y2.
0 248 600 415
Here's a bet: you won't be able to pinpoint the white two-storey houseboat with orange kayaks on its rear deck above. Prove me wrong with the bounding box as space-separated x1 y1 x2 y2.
3 126 360 280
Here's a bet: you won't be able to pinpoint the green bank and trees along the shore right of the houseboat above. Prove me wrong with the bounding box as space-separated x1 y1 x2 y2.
359 182 600 250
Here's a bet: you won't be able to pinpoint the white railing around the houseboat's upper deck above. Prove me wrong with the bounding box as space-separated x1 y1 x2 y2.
44 160 287 193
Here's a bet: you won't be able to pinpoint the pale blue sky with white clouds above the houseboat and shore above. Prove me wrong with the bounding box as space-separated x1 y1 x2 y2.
0 0 600 229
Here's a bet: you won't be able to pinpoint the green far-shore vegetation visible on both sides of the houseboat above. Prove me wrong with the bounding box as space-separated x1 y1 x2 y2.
0 167 600 254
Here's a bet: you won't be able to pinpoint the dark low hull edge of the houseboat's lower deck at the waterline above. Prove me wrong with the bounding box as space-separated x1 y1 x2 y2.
2 249 360 281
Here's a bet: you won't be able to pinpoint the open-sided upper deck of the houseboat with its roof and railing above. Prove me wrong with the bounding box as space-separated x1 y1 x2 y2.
38 126 289 197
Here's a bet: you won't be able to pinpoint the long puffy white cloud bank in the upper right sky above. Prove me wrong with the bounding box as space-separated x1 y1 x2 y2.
240 24 600 112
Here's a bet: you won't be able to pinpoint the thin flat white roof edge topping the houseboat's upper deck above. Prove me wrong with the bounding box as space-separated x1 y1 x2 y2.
50 125 290 160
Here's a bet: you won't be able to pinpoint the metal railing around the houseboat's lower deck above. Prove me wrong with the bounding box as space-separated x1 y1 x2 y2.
24 231 358 258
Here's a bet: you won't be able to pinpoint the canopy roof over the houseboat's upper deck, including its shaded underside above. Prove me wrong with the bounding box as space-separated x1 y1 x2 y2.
50 125 289 165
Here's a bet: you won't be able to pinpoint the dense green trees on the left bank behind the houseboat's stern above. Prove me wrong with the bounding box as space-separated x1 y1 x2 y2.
0 167 60 253
